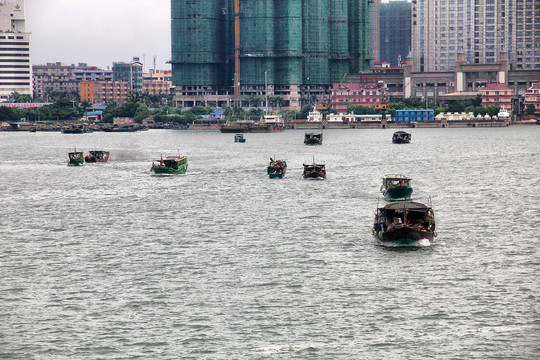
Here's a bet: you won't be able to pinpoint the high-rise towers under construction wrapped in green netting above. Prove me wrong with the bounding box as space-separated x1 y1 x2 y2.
171 0 370 109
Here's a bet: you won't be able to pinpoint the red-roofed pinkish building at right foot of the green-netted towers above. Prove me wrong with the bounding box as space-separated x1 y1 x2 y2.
330 82 387 112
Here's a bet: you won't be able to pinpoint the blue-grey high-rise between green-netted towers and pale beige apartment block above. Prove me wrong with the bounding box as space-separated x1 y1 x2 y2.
377 0 411 66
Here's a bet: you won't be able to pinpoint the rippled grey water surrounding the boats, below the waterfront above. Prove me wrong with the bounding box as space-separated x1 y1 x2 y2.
0 126 540 359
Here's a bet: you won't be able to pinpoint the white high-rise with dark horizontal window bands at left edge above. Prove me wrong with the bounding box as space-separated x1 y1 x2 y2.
0 0 32 101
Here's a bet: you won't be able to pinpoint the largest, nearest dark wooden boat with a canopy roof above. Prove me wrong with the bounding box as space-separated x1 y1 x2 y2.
372 201 437 245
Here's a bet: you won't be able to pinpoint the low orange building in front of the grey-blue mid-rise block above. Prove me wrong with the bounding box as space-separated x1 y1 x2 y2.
80 81 131 105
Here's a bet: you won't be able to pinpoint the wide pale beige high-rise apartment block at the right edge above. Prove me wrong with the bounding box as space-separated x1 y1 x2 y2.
411 0 540 72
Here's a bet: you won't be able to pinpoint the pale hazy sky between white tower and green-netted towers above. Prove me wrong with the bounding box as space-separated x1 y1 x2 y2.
25 0 171 70
